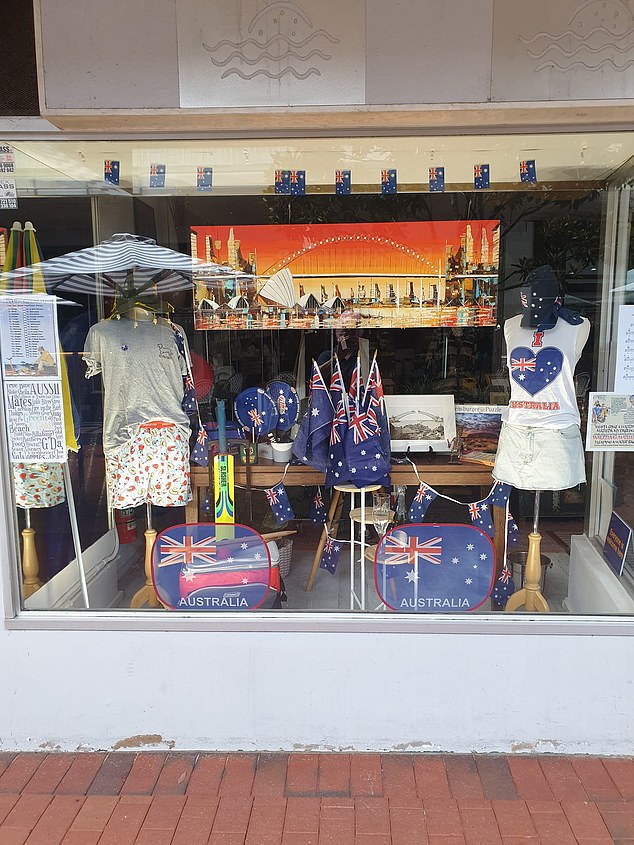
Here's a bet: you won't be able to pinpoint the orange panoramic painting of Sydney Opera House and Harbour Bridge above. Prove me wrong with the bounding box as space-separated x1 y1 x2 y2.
191 220 500 330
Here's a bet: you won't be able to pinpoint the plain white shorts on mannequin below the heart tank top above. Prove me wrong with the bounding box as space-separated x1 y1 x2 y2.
493 423 586 490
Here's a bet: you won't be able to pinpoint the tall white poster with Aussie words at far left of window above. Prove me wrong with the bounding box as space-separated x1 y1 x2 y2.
0 294 67 463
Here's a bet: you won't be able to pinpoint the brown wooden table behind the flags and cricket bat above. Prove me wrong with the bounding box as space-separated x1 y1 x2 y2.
185 455 506 591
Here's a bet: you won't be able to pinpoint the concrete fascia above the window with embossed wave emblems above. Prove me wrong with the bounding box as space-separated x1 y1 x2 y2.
36 0 634 110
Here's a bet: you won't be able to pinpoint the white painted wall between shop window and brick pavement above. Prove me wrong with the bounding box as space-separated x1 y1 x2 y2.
0 616 634 754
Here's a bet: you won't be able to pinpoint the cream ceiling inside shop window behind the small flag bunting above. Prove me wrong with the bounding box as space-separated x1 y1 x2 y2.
6 132 634 196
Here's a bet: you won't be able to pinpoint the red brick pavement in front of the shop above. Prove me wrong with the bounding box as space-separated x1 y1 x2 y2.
0 751 634 845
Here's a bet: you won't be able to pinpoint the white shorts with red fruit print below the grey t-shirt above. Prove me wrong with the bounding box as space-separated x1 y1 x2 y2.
106 423 192 510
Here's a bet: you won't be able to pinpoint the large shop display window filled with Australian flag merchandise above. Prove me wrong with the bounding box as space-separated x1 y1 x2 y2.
0 133 634 616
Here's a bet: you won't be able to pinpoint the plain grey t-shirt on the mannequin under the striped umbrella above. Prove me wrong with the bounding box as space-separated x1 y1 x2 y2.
84 317 189 452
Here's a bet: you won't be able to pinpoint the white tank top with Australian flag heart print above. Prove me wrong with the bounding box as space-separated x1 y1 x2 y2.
504 314 590 428
